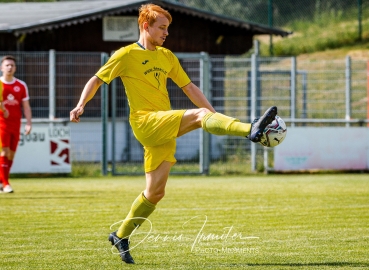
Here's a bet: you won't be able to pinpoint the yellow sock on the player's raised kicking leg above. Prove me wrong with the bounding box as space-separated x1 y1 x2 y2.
201 113 251 137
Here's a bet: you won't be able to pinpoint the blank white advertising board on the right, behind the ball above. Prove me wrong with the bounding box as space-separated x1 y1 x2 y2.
274 127 369 171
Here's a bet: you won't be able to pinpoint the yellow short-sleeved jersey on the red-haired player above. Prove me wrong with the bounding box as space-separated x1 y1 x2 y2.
95 43 191 113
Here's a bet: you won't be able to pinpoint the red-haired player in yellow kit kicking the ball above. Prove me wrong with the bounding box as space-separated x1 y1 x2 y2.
70 4 277 263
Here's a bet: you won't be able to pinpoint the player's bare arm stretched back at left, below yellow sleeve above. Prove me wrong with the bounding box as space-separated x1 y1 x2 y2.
70 76 103 123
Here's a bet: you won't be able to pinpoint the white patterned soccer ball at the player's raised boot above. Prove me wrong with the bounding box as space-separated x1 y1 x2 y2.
260 115 287 147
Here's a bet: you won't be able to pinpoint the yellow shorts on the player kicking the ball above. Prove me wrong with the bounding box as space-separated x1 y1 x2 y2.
129 110 186 172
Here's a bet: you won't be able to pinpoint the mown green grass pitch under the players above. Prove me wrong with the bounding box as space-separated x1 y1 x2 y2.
0 174 369 269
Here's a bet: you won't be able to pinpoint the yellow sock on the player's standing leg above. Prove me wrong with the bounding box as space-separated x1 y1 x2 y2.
117 192 156 238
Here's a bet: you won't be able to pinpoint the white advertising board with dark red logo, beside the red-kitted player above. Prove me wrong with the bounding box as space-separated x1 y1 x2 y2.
11 124 72 173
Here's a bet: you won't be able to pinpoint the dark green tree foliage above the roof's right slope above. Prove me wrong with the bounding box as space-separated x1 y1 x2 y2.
173 0 358 27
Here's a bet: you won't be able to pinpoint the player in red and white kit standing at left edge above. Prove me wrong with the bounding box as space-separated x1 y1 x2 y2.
0 55 32 193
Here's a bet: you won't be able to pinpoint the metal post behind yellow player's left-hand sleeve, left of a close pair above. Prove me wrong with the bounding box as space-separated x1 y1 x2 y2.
100 53 108 175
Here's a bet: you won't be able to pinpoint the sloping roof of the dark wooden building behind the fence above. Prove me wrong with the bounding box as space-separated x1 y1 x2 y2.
0 0 291 37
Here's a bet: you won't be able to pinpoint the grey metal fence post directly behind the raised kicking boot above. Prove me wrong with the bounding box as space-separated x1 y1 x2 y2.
250 54 258 172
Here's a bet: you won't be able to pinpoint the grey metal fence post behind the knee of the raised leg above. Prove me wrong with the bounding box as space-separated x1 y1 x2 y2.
199 52 211 174
